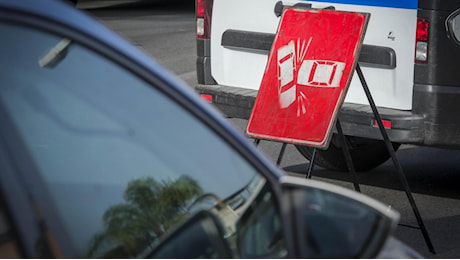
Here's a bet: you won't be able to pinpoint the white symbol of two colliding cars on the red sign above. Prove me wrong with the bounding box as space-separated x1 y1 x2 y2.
277 38 345 116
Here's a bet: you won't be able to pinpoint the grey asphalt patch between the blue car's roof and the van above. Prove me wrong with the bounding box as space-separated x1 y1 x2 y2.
77 0 197 86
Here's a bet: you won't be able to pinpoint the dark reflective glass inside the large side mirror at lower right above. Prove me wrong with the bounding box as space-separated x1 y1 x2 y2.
301 188 381 258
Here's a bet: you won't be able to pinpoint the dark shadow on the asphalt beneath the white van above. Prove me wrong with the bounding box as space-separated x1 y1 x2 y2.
284 147 460 199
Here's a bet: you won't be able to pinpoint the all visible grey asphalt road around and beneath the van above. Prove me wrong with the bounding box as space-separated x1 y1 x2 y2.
77 0 460 258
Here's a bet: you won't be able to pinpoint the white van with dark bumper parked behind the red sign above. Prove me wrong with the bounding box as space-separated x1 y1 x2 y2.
196 0 460 171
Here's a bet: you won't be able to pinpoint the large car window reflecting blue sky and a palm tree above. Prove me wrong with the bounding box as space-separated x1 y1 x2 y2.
0 24 265 258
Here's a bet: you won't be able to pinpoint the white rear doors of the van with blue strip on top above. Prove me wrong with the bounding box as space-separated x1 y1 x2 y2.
211 0 418 110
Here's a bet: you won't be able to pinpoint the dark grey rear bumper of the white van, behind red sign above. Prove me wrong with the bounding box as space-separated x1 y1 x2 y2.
195 85 425 144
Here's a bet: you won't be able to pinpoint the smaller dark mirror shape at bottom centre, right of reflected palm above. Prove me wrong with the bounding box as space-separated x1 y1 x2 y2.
146 210 233 259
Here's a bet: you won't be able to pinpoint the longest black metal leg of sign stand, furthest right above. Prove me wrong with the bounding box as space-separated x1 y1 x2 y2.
356 64 436 254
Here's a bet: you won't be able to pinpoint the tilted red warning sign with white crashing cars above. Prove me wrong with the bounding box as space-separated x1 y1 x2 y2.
246 8 369 148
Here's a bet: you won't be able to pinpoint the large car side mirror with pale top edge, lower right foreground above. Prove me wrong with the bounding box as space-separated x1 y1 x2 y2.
281 176 399 258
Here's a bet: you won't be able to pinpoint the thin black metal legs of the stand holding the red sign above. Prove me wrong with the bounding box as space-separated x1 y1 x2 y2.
254 64 436 254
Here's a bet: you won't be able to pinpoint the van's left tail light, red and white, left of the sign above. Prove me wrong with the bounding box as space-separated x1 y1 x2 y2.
196 0 213 39
